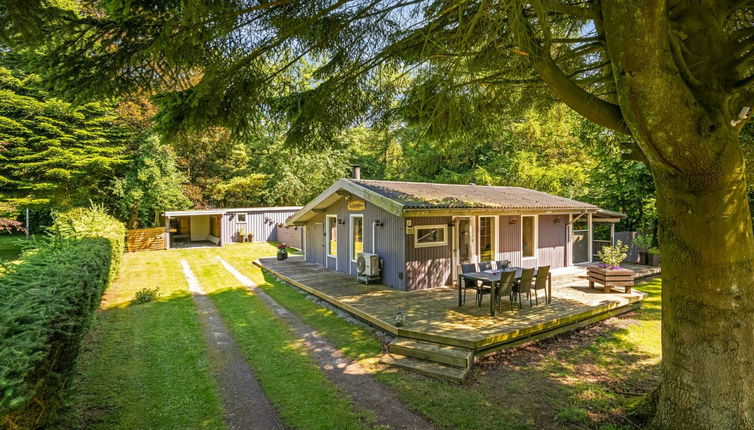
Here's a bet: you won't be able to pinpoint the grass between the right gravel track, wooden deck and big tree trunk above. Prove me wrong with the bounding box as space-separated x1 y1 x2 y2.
212 247 661 429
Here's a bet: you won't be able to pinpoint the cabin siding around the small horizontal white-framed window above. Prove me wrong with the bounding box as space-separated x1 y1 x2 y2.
405 217 453 290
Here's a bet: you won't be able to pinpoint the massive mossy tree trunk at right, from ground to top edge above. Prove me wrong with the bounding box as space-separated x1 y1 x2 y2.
601 0 754 429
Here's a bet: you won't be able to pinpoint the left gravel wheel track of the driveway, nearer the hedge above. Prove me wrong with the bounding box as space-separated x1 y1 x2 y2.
181 260 285 430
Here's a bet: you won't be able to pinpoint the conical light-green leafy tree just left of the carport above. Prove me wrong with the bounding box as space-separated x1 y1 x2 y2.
113 136 191 228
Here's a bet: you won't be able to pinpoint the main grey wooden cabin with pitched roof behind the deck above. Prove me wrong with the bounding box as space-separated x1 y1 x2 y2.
287 179 625 290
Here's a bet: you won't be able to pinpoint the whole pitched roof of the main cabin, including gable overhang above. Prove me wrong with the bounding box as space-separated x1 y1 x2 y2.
287 179 625 224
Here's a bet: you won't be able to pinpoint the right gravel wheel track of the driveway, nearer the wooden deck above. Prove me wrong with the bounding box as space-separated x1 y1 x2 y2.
217 257 433 429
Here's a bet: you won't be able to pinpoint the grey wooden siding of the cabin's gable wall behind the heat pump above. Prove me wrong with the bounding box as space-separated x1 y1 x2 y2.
306 199 405 289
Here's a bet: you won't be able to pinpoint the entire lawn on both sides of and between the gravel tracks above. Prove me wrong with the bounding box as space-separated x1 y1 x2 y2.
66 244 661 429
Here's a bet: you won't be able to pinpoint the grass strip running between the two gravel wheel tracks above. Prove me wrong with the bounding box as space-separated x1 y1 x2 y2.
181 249 373 429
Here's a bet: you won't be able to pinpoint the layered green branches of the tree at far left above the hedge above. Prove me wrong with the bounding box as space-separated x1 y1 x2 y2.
0 53 133 208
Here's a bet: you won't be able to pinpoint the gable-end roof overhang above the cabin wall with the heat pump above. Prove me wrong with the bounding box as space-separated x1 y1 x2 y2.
286 179 403 225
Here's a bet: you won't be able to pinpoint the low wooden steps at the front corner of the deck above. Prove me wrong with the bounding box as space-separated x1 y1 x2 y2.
380 337 474 382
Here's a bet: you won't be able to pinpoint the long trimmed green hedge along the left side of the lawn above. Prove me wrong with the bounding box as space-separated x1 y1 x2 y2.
0 207 125 428
